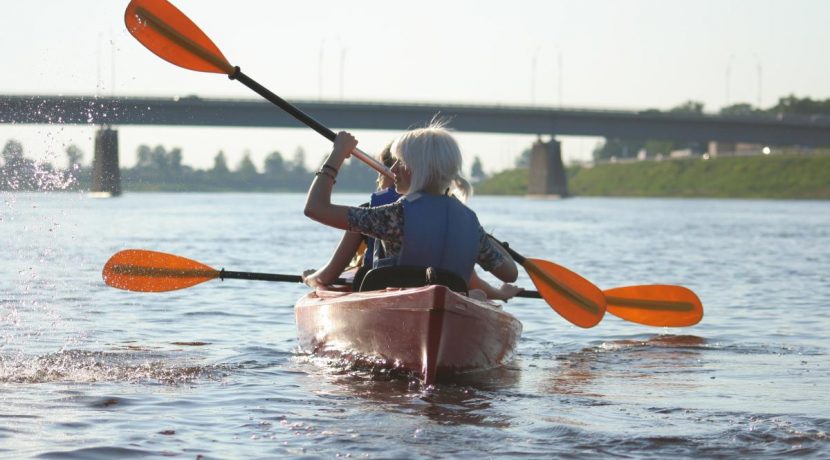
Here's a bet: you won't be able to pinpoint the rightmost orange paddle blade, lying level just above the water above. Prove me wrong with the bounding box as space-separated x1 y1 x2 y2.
605 284 703 327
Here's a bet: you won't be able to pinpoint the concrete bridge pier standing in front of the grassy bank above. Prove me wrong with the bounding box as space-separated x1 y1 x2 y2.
527 138 568 198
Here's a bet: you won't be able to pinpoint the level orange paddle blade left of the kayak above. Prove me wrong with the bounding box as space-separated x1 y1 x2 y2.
102 249 219 292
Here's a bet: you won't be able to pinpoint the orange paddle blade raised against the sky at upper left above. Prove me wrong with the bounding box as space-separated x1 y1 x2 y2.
124 0 234 75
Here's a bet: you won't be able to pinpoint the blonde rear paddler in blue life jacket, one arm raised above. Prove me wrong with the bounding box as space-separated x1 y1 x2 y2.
305 123 518 297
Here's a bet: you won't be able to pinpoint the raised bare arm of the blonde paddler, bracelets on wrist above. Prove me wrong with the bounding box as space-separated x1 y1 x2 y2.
304 131 357 230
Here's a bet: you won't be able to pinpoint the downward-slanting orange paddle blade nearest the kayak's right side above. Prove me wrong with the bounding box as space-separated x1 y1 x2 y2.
522 259 605 328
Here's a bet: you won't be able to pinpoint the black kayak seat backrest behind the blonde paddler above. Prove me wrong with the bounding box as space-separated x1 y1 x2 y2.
359 265 467 295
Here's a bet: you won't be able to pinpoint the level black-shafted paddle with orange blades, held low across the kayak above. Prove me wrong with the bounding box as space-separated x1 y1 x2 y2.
102 249 703 326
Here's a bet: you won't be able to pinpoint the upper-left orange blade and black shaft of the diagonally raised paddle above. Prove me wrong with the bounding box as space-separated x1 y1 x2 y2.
124 0 394 178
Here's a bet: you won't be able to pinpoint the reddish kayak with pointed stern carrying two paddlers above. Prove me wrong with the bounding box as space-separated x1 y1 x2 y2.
294 285 522 385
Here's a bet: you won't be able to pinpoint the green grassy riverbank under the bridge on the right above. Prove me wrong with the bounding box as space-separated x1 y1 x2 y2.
476 154 830 199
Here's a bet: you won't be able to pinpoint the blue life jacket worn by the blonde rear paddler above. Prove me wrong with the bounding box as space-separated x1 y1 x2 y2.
373 193 479 282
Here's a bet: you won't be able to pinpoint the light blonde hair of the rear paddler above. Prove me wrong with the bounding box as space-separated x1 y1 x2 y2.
391 118 473 201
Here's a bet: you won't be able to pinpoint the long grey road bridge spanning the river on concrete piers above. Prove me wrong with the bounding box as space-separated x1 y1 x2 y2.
0 95 830 193
